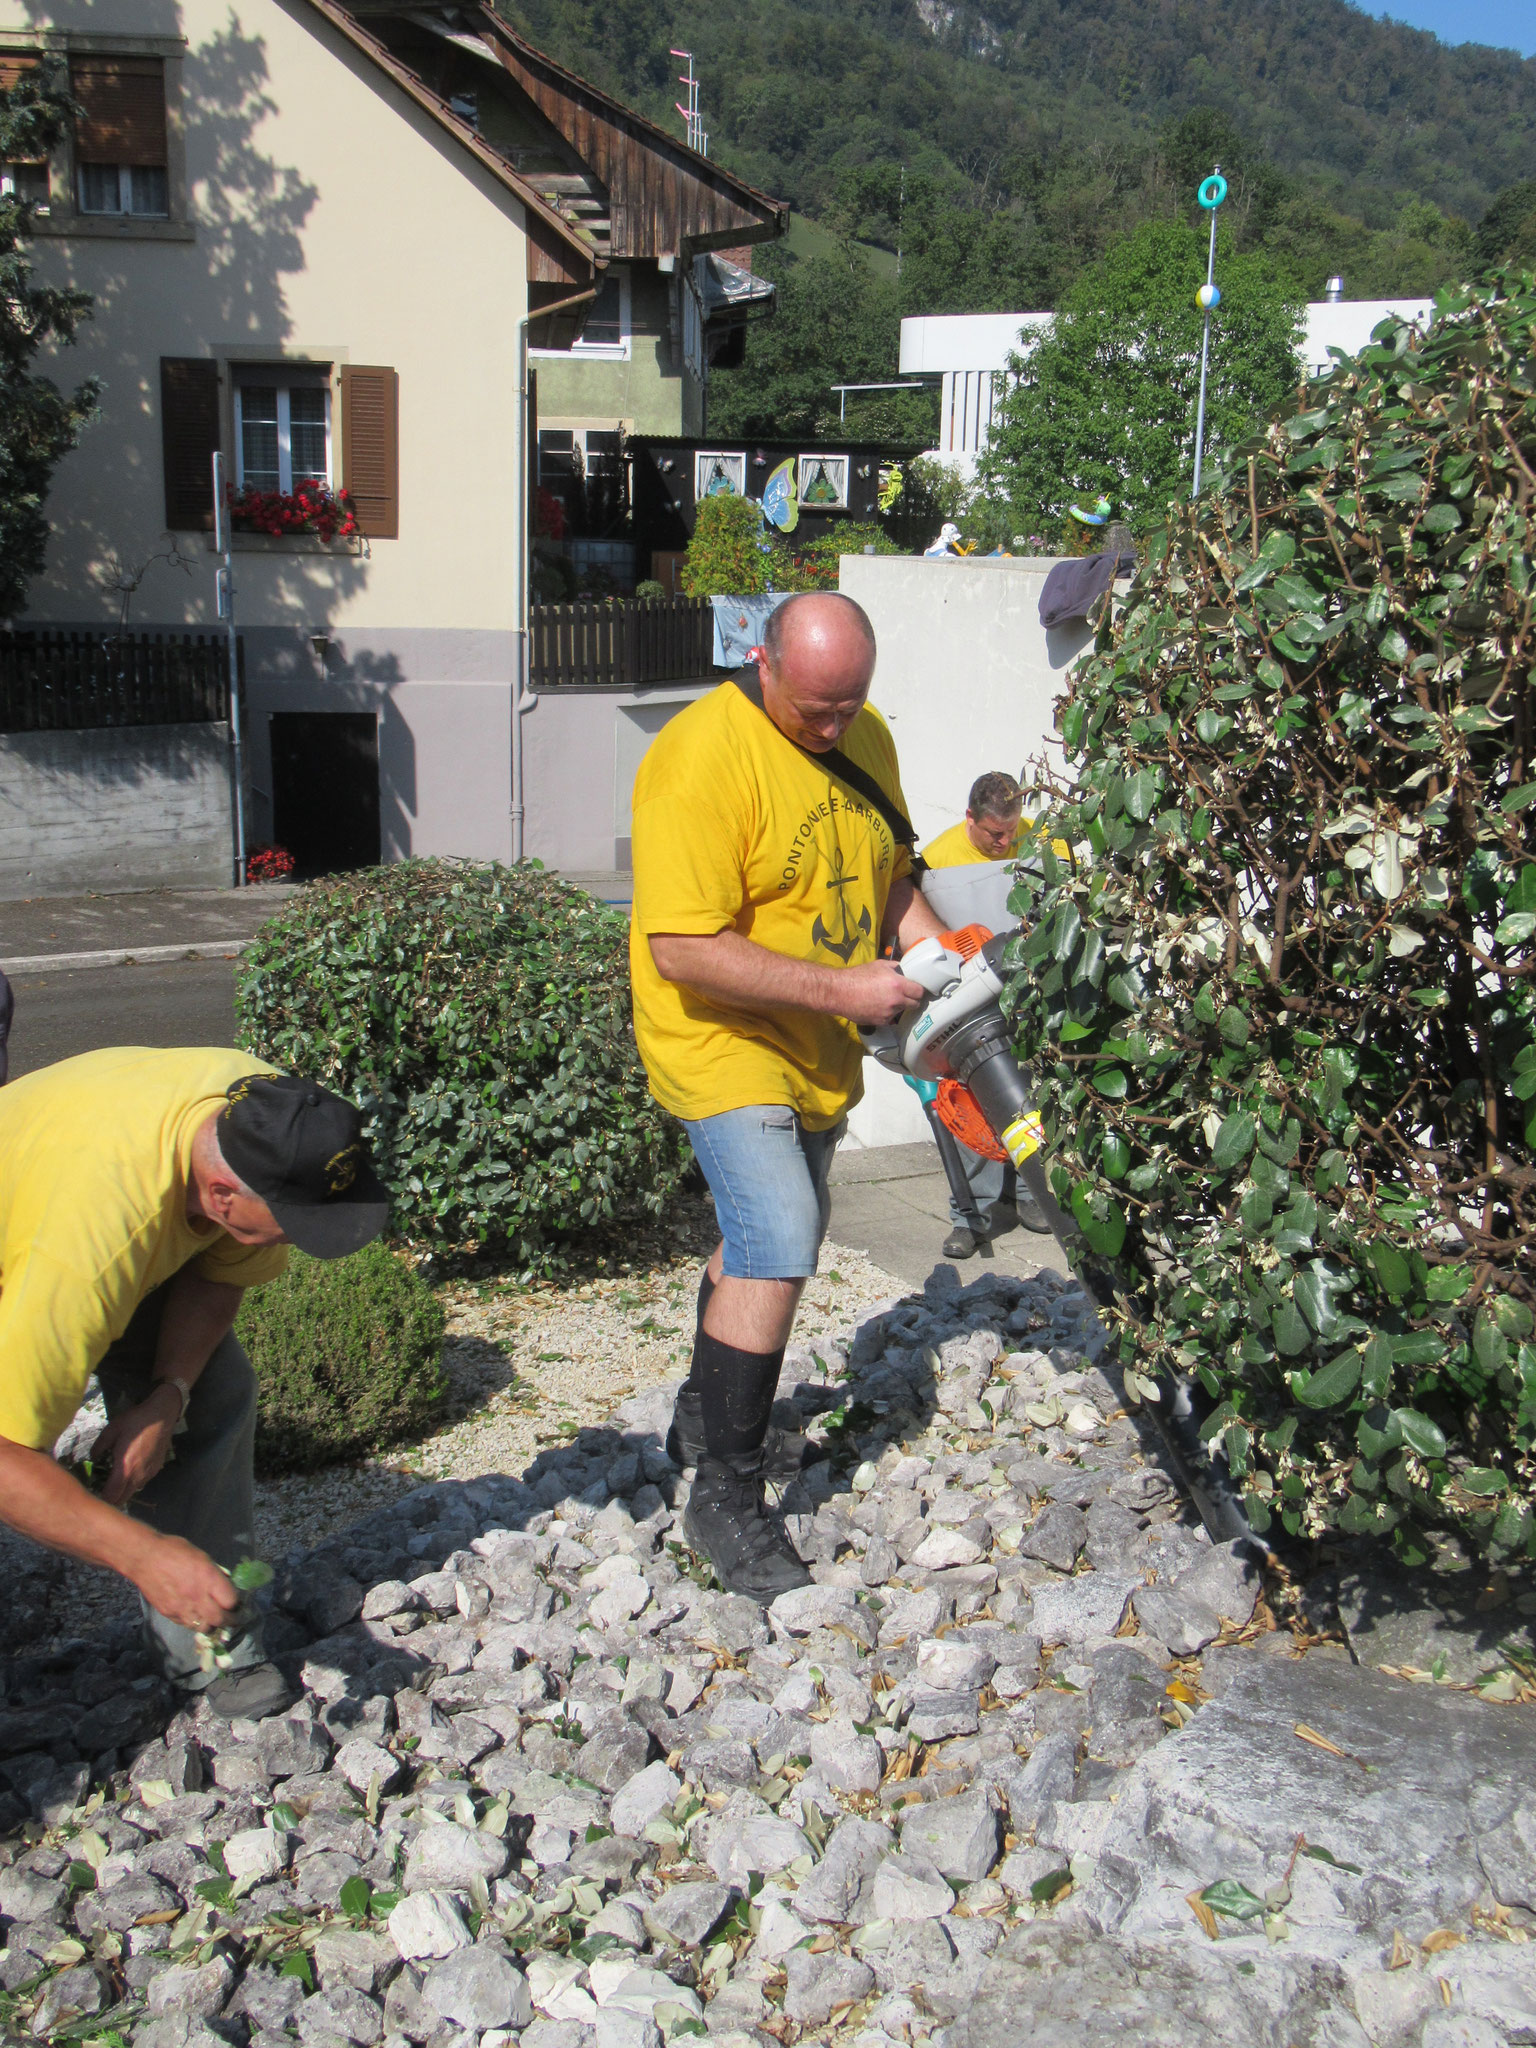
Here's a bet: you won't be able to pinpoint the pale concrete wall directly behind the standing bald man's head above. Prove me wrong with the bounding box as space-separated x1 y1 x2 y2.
840 555 1090 840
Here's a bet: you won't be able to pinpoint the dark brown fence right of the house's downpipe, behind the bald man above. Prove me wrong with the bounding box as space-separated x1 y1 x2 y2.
528 598 715 690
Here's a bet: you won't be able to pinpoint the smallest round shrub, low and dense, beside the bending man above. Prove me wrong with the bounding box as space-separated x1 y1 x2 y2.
236 1243 449 1473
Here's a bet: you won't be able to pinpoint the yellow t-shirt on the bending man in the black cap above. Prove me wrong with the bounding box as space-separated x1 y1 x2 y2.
0 1047 289 1450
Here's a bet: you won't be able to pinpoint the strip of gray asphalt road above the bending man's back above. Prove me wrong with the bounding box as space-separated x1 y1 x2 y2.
10 961 236 1081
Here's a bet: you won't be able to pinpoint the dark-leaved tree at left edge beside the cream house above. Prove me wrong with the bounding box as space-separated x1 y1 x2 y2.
0 68 98 618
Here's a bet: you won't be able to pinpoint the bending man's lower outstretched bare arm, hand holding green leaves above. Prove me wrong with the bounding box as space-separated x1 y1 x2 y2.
0 1436 240 1628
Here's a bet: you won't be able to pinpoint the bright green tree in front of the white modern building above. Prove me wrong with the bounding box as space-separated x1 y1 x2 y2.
981 221 1300 530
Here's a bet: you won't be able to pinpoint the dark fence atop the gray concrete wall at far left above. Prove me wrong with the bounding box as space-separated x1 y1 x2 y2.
0 631 229 733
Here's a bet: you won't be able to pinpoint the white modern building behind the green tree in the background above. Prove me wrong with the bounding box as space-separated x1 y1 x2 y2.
901 297 1434 477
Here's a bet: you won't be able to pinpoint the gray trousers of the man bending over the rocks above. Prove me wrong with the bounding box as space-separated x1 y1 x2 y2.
96 1296 266 1692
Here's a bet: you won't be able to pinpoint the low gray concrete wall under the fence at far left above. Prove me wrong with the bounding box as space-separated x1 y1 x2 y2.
0 725 233 901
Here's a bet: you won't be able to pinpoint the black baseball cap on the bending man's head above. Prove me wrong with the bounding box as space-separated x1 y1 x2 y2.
219 1073 389 1260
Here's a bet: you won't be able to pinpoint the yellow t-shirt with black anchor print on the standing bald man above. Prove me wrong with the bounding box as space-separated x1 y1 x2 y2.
629 682 911 1130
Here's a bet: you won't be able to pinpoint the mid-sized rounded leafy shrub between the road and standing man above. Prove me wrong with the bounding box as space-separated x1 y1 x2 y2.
236 860 686 1272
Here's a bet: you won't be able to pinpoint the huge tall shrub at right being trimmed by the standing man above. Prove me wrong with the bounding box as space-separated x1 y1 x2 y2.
1010 276 1536 1561
